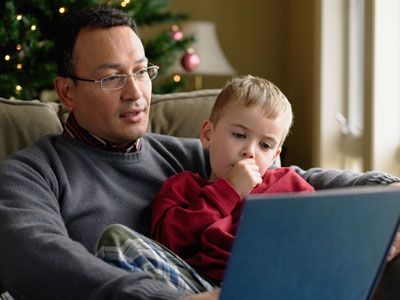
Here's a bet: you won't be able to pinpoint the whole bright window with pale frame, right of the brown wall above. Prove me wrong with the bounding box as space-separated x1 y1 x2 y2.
315 0 400 175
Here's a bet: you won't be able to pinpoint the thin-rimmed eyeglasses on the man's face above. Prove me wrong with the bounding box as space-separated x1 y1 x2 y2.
68 65 159 91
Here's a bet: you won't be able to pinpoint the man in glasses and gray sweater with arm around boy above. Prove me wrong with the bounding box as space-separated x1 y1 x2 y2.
0 7 397 300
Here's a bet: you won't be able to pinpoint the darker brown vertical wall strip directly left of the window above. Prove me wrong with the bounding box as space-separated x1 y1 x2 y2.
286 0 318 168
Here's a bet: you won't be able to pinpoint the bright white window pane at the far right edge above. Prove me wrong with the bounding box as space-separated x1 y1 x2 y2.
364 0 400 175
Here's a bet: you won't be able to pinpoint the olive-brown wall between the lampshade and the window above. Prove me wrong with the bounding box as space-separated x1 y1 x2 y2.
169 0 314 168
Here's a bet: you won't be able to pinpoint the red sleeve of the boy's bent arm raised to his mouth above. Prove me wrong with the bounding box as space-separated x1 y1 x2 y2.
151 172 242 250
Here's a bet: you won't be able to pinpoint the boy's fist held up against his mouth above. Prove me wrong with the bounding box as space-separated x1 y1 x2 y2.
226 158 262 198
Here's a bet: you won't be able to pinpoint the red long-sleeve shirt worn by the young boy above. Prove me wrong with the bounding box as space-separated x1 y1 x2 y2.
151 168 314 281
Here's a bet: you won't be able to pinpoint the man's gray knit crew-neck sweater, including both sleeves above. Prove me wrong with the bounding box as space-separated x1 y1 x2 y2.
0 134 397 300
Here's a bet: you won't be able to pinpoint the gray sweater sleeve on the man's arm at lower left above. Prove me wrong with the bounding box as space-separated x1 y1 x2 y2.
0 158 182 300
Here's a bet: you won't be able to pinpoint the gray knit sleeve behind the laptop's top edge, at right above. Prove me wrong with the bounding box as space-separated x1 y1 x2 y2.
291 166 400 190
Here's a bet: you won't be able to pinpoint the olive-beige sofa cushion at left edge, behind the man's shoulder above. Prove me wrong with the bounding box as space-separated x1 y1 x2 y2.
0 98 62 160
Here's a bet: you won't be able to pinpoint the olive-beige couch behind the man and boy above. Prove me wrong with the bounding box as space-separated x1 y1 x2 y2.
0 89 400 300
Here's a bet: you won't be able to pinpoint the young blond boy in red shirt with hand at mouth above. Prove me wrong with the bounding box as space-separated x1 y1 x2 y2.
151 76 314 283
